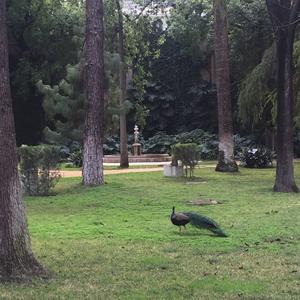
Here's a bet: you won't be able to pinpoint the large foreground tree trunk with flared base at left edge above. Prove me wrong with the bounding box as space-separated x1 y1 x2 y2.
0 0 46 281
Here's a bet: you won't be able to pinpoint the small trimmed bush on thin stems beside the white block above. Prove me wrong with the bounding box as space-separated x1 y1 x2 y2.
172 143 201 177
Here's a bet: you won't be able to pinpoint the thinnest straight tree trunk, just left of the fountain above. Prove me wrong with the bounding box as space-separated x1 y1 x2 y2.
116 0 129 168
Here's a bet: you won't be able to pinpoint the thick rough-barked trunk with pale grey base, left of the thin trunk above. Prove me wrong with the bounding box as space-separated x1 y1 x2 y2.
82 0 104 185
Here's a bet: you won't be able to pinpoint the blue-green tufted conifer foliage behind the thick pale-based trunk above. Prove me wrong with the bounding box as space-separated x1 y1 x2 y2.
37 52 125 145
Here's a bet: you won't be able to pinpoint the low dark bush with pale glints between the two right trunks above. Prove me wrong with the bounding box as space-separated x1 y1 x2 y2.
239 147 276 168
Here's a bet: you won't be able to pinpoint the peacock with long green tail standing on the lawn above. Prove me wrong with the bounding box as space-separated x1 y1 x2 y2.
171 206 227 237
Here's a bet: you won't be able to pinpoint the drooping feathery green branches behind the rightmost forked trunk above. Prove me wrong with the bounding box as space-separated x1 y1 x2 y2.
238 36 300 138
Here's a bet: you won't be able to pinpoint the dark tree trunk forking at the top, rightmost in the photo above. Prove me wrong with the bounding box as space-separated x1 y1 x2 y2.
266 0 300 192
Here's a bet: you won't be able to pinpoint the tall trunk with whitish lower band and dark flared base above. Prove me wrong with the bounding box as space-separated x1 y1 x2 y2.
214 0 238 172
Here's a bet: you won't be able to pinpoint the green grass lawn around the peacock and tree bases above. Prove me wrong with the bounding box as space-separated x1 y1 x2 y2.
0 164 300 300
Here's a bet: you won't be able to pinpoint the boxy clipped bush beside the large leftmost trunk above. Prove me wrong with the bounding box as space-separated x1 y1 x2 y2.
18 145 61 196
